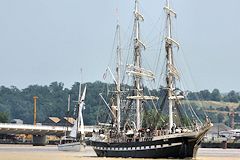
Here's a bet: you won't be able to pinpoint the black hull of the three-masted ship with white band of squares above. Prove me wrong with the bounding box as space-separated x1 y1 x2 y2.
91 127 210 158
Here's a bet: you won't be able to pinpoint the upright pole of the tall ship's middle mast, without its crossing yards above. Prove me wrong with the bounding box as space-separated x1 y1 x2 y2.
134 0 144 130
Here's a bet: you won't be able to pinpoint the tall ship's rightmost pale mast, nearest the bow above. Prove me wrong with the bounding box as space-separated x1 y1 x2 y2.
164 0 182 133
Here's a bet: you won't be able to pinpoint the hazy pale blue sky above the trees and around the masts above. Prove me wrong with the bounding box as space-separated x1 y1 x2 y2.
0 0 240 92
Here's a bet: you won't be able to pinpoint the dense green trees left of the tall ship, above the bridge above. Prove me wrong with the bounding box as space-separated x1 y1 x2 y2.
0 82 106 124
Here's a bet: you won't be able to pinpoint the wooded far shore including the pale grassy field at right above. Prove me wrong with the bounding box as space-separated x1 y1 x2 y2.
0 81 240 125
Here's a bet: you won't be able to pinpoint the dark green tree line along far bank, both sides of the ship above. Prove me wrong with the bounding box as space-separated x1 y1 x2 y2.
0 81 240 125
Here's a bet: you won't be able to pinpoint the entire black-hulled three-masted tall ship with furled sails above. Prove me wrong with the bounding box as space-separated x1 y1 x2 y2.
91 0 212 158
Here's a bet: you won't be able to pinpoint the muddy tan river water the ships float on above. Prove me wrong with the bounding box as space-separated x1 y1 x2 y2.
0 144 240 160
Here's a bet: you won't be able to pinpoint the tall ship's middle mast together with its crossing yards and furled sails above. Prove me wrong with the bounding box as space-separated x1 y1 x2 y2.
127 0 158 130
